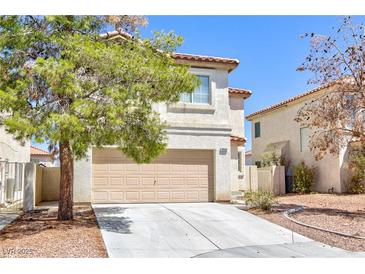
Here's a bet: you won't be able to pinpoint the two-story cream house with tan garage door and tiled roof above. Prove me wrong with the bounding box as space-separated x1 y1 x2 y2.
74 33 251 203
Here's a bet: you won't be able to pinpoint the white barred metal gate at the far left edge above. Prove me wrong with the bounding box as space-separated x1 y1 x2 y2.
0 161 25 212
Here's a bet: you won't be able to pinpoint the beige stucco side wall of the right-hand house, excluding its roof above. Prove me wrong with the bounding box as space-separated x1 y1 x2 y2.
251 88 343 192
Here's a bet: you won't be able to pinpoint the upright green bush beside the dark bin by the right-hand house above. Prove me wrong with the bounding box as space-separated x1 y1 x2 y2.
293 162 314 193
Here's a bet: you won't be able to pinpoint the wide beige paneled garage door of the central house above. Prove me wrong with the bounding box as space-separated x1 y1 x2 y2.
92 148 213 203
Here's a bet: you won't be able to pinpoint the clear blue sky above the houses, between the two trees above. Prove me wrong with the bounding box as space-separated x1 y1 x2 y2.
142 16 356 149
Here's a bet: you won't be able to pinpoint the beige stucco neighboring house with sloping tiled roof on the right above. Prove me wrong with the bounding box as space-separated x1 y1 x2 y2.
246 85 347 193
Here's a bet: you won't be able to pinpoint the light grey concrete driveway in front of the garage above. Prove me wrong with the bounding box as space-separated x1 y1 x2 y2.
93 203 363 258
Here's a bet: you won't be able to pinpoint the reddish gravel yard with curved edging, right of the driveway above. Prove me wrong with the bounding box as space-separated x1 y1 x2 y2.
245 194 365 251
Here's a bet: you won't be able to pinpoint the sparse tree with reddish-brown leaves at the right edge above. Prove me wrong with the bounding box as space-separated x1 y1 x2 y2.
295 17 365 159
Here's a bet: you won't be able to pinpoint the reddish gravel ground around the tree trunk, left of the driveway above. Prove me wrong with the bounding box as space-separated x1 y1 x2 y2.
0 206 107 258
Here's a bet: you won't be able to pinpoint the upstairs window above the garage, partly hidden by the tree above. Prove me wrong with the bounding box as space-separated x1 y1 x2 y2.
180 75 210 104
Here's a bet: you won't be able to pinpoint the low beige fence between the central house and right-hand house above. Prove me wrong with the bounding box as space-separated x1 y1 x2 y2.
243 165 285 195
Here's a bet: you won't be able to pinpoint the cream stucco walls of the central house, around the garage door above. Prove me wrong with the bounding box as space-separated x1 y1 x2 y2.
74 68 244 202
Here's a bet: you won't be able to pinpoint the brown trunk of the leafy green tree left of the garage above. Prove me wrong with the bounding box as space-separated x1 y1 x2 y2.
58 142 74 220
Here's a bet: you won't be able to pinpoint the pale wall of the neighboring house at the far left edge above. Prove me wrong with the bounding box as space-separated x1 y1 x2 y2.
0 127 30 163
